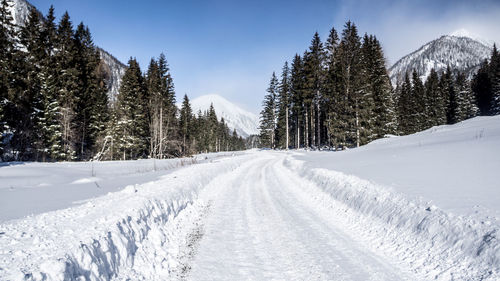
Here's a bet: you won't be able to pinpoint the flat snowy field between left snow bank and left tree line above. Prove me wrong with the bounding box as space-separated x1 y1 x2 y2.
0 152 242 222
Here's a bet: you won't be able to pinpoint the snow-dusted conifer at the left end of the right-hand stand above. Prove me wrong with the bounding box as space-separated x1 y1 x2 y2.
260 72 278 149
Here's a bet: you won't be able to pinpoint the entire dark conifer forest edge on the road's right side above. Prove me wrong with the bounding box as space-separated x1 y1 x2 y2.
260 22 500 149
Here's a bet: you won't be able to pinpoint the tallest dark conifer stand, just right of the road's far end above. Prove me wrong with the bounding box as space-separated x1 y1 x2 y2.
261 22 397 148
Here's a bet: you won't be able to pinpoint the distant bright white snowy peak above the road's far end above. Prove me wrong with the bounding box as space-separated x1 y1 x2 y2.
187 95 259 138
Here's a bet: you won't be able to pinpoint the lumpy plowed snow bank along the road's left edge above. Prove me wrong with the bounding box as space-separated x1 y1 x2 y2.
0 155 250 280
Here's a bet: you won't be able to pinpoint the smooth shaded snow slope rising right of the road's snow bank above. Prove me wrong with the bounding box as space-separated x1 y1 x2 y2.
297 116 500 215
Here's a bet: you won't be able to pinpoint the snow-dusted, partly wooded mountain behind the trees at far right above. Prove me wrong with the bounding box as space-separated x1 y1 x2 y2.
389 30 492 85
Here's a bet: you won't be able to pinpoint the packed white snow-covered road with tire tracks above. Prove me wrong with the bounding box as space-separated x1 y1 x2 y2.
189 153 415 280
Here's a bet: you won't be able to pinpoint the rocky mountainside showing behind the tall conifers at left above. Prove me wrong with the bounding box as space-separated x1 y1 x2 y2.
7 0 127 103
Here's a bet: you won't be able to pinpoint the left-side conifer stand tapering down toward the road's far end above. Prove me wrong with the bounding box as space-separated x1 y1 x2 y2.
98 57 245 160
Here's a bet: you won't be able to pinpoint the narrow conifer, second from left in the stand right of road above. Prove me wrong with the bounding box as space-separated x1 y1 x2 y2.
276 62 290 149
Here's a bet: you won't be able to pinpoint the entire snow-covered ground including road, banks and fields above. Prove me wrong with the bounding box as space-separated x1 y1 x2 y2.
0 116 500 280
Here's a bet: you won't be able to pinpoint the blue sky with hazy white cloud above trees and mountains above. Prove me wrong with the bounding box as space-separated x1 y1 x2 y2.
30 0 500 113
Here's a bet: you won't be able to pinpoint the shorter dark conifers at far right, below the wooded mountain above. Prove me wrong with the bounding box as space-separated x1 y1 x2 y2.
396 46 500 134
